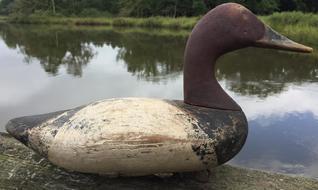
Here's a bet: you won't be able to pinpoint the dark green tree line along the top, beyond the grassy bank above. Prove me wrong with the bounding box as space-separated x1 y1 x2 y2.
0 0 318 17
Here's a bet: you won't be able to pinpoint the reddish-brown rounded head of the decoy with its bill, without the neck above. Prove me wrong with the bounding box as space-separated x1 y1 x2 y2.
188 3 313 58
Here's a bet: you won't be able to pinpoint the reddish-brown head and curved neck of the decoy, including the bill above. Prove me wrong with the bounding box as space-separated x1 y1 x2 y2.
184 3 312 110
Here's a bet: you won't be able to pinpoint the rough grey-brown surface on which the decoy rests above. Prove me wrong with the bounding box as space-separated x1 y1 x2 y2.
0 133 318 190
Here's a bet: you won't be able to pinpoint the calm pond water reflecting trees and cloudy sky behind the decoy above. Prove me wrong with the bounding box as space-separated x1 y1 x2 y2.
0 24 318 178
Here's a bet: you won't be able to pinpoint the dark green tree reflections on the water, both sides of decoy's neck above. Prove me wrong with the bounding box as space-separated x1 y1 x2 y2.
0 25 318 98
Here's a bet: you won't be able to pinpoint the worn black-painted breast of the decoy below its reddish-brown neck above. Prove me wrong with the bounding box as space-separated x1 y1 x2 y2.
170 101 248 165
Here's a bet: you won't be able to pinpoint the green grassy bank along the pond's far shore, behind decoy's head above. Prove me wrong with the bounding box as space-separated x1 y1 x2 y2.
4 12 318 46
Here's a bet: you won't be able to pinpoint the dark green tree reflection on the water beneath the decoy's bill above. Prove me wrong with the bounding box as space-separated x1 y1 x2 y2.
217 48 318 98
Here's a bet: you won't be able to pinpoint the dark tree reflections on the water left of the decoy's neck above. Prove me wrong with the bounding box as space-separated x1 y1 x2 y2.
1 25 185 81
